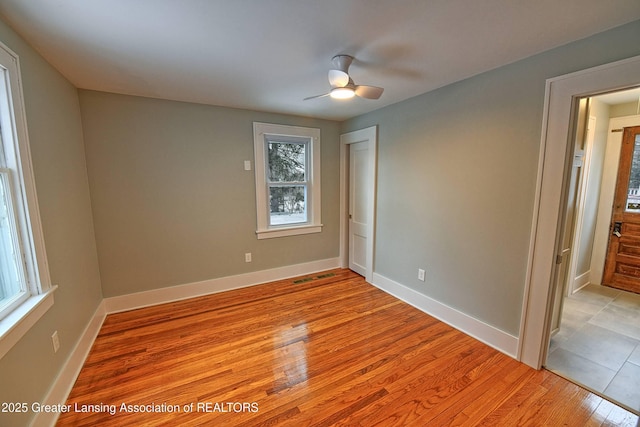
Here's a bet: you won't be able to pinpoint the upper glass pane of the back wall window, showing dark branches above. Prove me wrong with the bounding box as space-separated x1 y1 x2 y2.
267 141 307 182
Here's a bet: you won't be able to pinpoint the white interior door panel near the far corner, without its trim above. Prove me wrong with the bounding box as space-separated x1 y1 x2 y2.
349 142 371 276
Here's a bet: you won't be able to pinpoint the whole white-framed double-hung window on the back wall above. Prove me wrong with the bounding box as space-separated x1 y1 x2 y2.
253 123 322 239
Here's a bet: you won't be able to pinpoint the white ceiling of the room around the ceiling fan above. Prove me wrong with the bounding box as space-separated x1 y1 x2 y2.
0 0 640 120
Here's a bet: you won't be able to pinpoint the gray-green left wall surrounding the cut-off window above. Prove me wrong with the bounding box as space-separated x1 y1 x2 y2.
0 18 102 426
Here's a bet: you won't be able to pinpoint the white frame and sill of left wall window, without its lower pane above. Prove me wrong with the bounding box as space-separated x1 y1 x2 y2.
0 43 57 358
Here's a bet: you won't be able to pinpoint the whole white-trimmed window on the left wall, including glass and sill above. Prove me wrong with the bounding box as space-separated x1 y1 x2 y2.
0 44 55 357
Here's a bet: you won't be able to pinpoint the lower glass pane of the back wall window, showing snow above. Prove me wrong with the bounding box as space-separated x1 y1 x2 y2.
269 185 307 225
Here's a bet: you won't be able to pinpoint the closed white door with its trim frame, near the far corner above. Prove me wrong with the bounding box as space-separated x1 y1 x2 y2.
340 126 377 283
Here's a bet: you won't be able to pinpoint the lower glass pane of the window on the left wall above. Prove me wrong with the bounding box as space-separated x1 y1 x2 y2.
0 172 25 308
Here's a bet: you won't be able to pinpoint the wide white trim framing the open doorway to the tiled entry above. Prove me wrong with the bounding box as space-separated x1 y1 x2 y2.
518 56 640 369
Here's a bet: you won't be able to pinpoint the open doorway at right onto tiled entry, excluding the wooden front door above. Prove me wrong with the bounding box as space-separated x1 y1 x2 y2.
544 90 640 413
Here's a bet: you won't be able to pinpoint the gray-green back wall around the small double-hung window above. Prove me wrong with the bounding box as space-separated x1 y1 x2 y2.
80 90 340 297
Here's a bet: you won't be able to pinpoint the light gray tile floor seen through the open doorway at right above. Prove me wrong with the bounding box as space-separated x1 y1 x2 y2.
546 285 640 413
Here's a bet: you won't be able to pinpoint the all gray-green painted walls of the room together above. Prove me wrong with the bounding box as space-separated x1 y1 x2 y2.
0 10 640 425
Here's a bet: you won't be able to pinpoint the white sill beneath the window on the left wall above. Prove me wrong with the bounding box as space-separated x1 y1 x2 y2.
0 286 58 359
